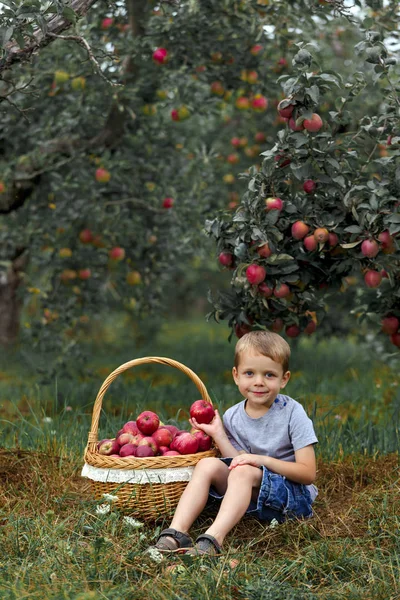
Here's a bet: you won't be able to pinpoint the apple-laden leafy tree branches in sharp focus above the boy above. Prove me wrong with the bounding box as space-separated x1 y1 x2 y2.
207 5 400 347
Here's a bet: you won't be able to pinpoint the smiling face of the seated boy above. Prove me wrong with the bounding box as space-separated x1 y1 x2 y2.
232 351 290 410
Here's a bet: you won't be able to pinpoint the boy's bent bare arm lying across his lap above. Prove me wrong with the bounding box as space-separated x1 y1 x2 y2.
229 444 317 485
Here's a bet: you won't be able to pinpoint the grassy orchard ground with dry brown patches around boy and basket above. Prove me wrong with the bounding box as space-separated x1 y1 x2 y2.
0 321 400 600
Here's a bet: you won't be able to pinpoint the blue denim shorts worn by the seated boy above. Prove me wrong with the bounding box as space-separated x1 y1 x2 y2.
209 458 313 523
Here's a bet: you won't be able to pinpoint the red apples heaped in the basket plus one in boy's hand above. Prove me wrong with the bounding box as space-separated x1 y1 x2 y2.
97 400 215 458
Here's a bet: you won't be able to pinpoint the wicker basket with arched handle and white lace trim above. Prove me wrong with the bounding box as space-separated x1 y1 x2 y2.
82 356 218 520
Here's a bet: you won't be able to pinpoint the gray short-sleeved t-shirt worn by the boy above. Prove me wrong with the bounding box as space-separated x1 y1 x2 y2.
222 394 318 499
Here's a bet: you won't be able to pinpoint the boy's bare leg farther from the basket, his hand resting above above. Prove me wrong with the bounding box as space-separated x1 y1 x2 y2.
206 465 262 545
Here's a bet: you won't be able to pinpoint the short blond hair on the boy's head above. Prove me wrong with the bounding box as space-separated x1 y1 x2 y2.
235 330 290 373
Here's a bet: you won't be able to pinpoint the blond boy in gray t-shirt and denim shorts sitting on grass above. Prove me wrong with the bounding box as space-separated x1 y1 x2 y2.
155 331 318 555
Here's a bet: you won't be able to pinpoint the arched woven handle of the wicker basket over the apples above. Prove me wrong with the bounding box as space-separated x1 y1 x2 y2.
87 356 212 452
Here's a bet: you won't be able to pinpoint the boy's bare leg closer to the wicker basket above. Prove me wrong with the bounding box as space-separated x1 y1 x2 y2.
166 458 229 533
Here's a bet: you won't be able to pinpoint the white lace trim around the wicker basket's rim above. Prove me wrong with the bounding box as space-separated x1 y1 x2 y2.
81 463 194 484
